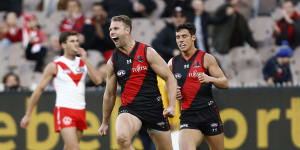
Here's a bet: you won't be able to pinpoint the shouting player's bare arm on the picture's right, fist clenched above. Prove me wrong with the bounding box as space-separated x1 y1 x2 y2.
146 47 177 116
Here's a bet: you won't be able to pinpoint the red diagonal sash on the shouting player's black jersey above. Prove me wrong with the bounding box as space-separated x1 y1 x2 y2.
121 43 149 106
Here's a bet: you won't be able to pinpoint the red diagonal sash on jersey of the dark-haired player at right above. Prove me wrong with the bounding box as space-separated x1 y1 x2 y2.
181 51 205 110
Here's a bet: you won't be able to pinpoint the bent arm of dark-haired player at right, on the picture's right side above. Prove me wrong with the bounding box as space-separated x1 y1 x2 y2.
199 53 228 88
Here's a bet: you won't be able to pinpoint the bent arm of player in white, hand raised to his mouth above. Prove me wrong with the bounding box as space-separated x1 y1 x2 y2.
79 48 103 85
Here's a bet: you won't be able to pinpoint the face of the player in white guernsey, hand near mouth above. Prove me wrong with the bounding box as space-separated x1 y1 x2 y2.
62 35 79 56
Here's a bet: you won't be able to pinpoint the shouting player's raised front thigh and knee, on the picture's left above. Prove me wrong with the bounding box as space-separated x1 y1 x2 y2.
116 113 142 150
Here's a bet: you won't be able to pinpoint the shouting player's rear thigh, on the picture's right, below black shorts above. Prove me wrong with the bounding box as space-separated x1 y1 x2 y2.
148 129 173 150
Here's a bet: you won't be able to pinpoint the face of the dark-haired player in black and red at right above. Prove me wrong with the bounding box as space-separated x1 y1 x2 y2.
176 29 196 52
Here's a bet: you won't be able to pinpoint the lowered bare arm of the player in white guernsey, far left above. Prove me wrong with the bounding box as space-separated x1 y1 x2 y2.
21 62 56 128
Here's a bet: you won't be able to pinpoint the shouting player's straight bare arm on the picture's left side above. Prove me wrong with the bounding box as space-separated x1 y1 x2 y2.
102 59 117 124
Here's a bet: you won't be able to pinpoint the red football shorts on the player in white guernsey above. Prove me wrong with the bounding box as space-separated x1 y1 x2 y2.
54 107 87 132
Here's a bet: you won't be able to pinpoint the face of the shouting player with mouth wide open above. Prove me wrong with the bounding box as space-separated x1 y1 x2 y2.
109 21 130 48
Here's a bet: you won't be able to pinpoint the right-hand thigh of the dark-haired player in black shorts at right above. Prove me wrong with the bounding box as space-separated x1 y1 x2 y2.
205 133 224 150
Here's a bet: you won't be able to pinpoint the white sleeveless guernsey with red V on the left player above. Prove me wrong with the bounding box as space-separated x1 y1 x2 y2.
53 56 87 109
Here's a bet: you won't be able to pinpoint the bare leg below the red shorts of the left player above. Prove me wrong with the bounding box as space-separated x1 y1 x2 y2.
60 127 79 150
